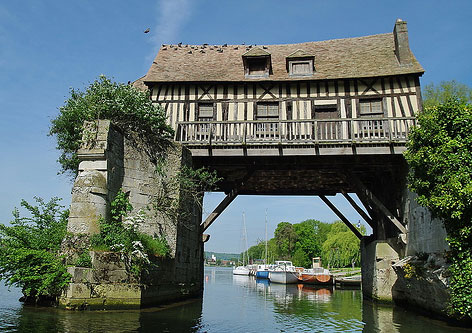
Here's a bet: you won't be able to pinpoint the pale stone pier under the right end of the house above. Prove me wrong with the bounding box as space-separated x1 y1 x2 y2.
361 189 449 317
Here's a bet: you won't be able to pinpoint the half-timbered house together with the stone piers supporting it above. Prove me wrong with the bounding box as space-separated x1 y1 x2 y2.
61 20 445 308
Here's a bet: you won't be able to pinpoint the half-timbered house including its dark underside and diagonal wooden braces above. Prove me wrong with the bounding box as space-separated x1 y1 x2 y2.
136 19 424 239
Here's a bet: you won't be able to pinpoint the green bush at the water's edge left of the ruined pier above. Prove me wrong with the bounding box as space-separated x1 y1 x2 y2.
0 197 71 299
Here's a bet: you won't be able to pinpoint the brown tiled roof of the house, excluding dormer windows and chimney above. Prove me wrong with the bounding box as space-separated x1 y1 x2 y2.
143 33 424 82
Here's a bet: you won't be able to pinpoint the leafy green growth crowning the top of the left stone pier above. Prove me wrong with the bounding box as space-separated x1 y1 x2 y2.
49 75 173 175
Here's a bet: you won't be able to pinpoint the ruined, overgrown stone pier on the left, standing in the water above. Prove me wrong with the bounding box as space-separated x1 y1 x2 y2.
60 120 203 309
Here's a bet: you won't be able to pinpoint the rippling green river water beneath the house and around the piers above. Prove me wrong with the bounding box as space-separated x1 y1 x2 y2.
0 267 472 333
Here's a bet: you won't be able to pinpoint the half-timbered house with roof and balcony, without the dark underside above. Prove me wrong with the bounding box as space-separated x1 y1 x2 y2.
139 20 424 159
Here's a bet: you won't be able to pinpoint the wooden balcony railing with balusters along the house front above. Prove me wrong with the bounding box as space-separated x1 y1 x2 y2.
176 117 416 145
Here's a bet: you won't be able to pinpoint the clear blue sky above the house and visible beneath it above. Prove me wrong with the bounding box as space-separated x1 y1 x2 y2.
0 0 472 252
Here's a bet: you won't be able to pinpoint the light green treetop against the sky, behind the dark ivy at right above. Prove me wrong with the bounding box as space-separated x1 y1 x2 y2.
423 80 472 107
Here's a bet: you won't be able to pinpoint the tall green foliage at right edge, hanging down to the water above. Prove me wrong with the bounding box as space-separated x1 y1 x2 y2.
405 99 472 318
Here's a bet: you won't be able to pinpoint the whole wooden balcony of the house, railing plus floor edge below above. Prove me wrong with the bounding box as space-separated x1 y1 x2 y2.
175 117 416 156
